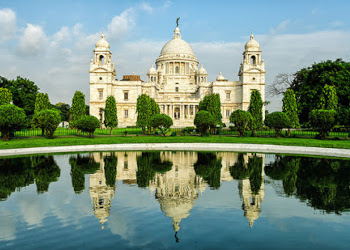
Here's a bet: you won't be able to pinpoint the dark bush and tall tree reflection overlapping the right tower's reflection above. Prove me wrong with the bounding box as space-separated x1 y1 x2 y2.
230 153 263 194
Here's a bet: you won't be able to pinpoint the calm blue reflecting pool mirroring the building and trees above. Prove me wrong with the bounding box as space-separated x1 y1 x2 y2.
0 151 350 249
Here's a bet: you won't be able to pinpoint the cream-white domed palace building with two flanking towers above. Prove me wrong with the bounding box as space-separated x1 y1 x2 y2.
89 23 265 127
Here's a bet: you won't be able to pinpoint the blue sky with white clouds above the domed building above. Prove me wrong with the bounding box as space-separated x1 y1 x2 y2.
0 0 350 111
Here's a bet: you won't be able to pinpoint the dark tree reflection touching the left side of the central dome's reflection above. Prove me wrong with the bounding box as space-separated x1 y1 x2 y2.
136 152 173 187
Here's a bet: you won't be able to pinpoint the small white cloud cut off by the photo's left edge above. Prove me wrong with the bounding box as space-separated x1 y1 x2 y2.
0 9 17 40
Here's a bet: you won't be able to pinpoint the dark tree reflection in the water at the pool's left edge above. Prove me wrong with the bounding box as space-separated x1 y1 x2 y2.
0 157 34 199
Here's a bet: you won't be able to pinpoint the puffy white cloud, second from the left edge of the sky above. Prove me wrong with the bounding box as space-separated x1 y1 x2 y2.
17 24 47 56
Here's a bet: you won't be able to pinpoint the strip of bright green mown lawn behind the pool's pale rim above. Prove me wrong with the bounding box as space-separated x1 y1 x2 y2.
0 135 350 150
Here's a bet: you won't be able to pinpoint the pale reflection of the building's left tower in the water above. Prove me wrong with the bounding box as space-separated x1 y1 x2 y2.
89 153 115 229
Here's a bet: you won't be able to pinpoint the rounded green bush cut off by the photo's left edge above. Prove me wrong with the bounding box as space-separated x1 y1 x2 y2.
0 104 27 141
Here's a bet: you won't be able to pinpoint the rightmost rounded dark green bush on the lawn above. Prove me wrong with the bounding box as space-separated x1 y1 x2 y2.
309 109 337 140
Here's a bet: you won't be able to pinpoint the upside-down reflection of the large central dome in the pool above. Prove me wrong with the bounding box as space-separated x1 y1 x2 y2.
150 152 207 232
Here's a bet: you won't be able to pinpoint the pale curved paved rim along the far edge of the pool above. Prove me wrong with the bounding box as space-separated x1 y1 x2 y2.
0 143 350 158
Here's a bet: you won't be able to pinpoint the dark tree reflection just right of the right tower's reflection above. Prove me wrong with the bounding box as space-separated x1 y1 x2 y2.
265 156 300 196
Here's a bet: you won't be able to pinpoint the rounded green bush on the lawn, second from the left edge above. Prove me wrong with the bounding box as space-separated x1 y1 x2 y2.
32 109 61 138
